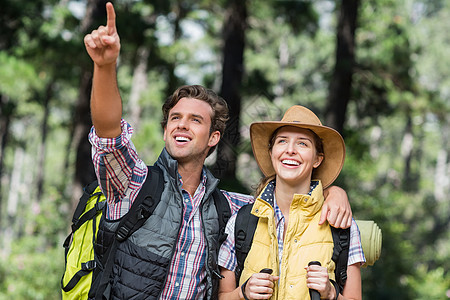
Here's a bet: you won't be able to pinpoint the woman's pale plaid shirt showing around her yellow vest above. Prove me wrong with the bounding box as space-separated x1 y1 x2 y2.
219 183 366 272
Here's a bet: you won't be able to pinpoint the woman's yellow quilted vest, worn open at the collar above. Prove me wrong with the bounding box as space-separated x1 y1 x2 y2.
239 181 335 300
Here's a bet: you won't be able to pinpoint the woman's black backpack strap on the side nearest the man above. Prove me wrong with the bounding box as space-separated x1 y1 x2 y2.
234 204 259 286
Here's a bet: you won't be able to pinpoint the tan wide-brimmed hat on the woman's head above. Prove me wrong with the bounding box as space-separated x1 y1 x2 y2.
250 105 345 188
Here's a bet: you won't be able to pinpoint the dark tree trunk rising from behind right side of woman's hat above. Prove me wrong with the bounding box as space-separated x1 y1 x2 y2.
325 0 359 134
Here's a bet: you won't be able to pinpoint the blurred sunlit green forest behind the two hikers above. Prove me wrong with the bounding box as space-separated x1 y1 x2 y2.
0 0 450 299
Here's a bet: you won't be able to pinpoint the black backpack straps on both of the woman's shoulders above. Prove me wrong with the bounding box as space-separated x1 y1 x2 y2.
234 204 350 291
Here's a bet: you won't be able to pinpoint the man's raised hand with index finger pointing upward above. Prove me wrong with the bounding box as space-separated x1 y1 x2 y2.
84 2 120 67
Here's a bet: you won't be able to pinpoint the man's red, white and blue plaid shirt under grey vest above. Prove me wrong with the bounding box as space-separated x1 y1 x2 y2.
89 120 254 299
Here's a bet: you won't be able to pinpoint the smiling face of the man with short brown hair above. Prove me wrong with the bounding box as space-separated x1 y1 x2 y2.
164 98 220 165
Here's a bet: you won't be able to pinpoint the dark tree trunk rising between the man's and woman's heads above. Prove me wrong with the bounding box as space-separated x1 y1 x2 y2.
212 0 247 180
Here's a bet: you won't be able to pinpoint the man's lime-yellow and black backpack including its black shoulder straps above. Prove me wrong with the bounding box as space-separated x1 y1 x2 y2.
61 166 231 300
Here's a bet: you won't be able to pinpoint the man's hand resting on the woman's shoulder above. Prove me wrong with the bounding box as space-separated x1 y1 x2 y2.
319 186 352 228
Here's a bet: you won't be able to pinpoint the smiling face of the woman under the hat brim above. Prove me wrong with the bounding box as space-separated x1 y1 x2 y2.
270 126 323 184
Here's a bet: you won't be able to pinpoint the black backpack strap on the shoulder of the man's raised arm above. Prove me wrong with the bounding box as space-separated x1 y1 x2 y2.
94 165 164 299
